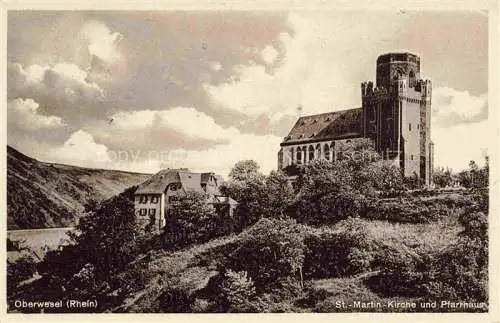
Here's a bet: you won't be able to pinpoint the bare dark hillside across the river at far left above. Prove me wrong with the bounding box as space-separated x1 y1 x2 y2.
7 146 149 230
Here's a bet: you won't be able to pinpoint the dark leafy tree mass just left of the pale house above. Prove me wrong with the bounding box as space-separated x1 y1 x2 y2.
39 187 147 286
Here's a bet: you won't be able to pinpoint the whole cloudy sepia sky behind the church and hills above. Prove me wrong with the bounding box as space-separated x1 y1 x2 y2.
7 10 489 175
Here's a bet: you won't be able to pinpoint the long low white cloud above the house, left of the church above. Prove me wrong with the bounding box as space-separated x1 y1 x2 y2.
84 107 281 175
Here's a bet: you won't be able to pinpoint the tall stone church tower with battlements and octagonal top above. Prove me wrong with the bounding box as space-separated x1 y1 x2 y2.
361 53 433 185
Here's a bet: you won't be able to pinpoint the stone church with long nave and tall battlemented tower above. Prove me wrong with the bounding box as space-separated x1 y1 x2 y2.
278 53 434 185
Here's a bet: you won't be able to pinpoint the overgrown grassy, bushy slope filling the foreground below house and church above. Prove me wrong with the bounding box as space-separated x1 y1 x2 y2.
9 189 486 313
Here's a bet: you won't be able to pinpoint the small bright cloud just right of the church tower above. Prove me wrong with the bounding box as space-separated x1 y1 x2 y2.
432 87 488 127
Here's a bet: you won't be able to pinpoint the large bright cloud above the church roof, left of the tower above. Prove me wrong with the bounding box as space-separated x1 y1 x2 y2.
205 12 410 125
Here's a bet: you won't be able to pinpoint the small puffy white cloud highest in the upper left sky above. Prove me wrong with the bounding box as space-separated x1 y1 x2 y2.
81 21 123 63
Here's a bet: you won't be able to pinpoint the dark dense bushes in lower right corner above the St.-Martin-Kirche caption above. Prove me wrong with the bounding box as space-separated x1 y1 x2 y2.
370 204 488 310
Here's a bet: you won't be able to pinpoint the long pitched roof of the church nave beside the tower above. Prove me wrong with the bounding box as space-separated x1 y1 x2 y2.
281 108 362 146
